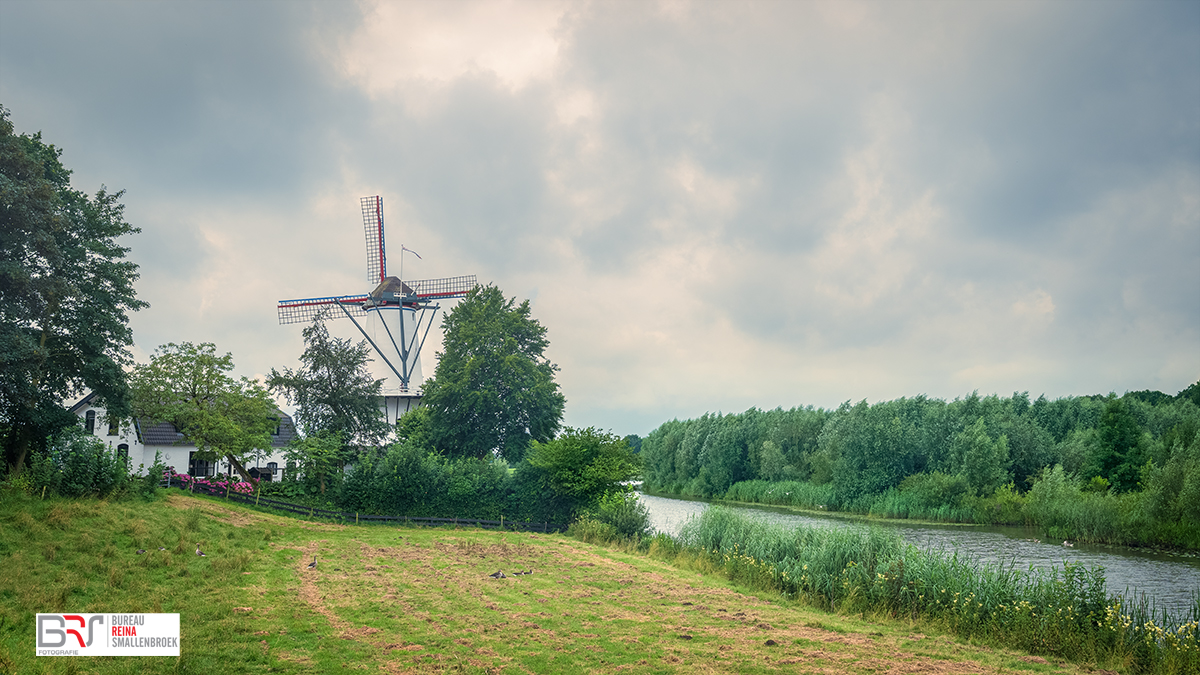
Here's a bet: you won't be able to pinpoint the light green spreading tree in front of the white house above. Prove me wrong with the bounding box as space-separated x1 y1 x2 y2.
131 342 278 482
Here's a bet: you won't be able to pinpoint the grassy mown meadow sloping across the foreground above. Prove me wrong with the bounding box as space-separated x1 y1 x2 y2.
0 492 1104 674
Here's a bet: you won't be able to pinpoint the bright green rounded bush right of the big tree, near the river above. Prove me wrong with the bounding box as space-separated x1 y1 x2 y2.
522 428 641 512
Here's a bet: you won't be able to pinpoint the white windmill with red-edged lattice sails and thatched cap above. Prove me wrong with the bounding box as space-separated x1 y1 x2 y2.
278 196 476 423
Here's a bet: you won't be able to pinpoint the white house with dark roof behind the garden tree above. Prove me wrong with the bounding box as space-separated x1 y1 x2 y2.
70 394 296 480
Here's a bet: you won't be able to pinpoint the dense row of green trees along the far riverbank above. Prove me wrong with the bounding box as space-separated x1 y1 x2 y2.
641 382 1200 548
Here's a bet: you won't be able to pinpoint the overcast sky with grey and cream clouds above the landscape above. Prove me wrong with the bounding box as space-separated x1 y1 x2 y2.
0 0 1200 435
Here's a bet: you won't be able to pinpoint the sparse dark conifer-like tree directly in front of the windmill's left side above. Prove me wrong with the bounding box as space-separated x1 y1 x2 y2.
266 317 389 446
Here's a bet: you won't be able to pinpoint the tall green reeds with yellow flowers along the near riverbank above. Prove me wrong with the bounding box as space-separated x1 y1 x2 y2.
676 507 1200 674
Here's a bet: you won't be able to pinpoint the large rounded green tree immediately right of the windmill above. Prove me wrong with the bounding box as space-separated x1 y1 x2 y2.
425 281 566 462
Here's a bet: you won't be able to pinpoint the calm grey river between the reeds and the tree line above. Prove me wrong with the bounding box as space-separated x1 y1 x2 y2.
638 485 1200 616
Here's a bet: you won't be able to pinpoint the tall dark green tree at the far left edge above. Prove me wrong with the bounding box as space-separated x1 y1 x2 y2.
0 107 148 472
